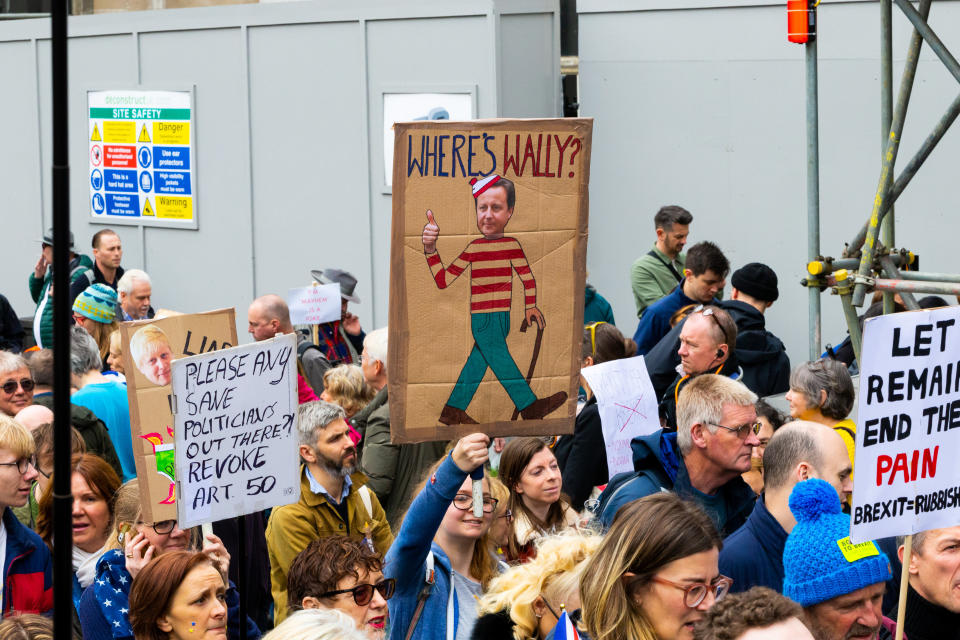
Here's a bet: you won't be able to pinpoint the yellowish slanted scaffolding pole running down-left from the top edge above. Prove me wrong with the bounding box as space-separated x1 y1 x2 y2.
851 0 931 307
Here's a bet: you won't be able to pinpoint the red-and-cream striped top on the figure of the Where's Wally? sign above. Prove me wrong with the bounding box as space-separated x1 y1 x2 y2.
427 237 537 313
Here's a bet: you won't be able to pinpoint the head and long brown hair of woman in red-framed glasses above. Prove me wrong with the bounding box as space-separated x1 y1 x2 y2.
580 493 732 640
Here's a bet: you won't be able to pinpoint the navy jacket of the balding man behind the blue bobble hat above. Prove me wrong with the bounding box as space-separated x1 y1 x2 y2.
720 496 787 593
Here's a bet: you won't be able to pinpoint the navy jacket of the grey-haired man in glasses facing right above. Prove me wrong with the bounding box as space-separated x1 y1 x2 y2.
600 429 756 537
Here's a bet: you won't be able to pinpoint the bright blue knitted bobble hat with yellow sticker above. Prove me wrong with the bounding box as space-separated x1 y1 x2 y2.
783 478 892 607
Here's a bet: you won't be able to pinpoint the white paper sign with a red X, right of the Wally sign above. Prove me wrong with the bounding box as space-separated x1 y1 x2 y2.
580 356 660 478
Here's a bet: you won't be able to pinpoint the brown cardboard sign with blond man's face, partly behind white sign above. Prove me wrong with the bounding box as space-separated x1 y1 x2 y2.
120 309 237 522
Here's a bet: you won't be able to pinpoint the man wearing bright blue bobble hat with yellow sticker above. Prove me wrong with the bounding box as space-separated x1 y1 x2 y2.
783 478 895 640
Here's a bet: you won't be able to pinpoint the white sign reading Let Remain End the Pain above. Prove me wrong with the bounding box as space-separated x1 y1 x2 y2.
850 307 960 542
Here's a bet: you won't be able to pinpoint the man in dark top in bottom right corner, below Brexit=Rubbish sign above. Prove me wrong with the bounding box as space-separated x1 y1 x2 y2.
897 526 960 640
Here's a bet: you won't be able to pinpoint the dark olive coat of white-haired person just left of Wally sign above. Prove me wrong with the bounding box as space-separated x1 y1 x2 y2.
351 387 447 528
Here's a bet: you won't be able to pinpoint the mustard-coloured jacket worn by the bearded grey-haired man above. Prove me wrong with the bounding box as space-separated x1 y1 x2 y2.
266 465 393 624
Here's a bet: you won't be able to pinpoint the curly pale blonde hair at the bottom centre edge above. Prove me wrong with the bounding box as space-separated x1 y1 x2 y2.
477 530 602 640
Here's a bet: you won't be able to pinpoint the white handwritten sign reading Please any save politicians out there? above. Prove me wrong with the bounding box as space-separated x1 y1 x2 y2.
172 334 300 528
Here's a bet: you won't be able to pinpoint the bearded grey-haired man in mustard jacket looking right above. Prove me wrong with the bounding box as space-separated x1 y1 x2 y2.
266 401 393 624
